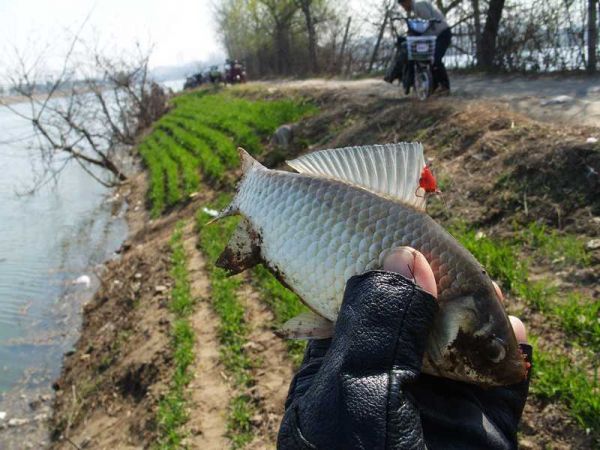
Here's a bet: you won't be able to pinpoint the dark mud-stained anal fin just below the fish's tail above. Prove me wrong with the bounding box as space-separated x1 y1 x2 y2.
215 219 261 275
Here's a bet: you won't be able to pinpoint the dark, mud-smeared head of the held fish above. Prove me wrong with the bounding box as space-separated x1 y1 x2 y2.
424 281 527 386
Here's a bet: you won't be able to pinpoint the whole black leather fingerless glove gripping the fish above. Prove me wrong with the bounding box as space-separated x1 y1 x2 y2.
278 272 530 450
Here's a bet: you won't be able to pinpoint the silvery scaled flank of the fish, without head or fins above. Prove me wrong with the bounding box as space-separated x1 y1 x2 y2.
241 169 471 320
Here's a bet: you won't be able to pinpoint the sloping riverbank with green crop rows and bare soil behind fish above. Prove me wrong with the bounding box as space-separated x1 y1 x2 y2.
52 84 600 449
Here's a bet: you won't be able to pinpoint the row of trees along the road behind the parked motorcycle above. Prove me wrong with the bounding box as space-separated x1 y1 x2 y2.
217 0 599 76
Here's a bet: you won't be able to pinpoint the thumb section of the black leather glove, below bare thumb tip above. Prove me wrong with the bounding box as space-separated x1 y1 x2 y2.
278 272 437 450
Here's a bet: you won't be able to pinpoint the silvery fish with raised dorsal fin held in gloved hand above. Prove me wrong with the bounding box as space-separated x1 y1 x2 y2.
214 142 527 386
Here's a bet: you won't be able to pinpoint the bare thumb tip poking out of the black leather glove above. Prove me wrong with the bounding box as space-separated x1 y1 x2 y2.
383 247 437 298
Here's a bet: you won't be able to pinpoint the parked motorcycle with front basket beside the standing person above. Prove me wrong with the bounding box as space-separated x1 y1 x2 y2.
386 17 439 100
